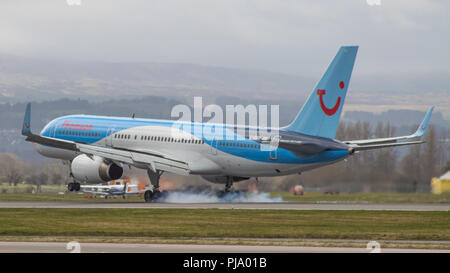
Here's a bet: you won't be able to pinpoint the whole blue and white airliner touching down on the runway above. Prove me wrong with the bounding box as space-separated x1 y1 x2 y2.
22 46 434 202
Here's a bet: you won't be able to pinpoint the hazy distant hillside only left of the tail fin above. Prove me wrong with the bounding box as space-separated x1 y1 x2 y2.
0 54 315 102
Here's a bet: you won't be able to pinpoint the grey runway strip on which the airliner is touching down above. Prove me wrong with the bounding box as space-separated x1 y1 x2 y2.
0 202 450 211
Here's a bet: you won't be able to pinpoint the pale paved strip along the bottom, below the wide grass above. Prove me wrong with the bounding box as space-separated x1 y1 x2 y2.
0 242 450 253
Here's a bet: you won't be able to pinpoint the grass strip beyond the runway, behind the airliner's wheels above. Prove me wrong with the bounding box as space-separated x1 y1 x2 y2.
0 192 450 204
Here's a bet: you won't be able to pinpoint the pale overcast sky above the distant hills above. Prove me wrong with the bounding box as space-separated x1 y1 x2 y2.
0 0 450 76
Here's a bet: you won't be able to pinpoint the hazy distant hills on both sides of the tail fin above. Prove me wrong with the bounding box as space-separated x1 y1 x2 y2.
0 54 450 119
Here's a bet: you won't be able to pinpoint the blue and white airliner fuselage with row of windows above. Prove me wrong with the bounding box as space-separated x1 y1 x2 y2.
37 115 349 177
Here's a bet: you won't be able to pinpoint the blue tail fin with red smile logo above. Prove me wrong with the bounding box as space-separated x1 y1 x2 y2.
284 46 358 139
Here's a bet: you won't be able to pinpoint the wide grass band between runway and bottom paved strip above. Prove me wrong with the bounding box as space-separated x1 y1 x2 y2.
0 209 450 240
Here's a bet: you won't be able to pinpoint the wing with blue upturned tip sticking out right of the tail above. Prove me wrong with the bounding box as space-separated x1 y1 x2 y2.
344 106 434 151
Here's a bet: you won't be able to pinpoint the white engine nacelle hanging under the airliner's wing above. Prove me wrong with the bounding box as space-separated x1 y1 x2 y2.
70 154 123 183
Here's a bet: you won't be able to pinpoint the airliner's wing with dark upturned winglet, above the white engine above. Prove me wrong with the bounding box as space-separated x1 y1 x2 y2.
22 103 190 175
